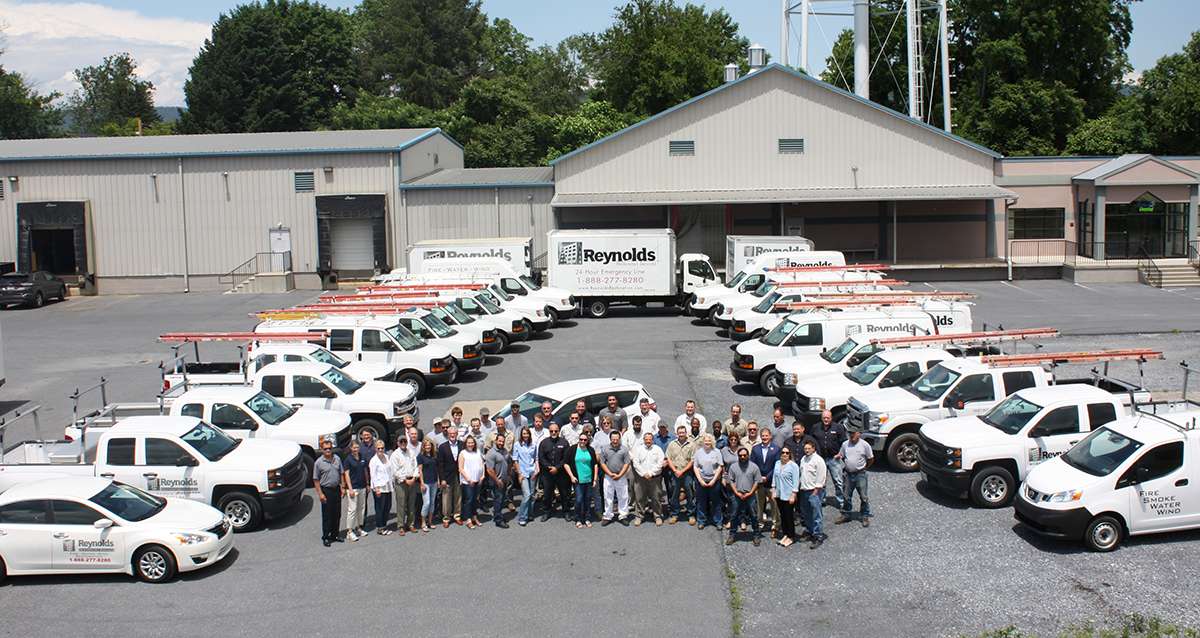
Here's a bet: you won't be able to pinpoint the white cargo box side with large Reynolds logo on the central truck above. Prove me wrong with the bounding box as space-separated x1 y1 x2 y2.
547 229 676 297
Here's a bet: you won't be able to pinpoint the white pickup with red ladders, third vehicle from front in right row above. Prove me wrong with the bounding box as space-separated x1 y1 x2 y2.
846 351 1162 471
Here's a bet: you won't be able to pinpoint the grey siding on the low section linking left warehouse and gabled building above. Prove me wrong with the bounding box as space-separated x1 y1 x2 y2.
396 187 554 264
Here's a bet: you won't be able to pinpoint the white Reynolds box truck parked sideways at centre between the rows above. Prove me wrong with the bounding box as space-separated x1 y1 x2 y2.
546 228 716 318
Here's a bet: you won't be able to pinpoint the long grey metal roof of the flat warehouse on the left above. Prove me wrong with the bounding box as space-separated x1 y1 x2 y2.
0 128 449 162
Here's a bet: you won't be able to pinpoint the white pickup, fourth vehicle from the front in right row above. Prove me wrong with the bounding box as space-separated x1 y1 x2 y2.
781 348 954 426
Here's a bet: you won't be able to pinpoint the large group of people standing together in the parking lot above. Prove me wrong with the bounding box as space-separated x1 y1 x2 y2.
313 396 874 549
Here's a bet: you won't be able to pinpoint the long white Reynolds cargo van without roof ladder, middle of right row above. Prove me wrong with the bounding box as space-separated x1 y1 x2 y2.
730 301 971 395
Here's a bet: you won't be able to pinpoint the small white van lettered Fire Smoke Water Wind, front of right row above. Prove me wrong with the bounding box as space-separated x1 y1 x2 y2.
1014 402 1200 552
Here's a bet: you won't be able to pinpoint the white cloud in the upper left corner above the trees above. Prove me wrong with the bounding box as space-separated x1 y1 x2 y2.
0 0 211 106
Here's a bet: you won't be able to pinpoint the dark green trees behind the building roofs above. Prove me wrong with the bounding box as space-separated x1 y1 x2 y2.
0 0 1200 161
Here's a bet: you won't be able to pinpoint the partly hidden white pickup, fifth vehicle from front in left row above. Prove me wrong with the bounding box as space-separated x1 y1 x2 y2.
163 336 396 391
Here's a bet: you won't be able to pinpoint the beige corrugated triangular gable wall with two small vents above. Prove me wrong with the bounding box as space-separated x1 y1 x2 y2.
554 72 995 193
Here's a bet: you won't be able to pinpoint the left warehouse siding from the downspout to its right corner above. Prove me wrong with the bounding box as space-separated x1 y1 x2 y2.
184 154 395 275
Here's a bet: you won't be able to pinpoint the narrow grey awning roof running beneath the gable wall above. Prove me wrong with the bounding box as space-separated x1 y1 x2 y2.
551 185 1016 207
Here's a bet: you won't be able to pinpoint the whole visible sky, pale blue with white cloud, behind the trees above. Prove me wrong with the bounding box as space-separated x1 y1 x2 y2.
0 0 1200 106
